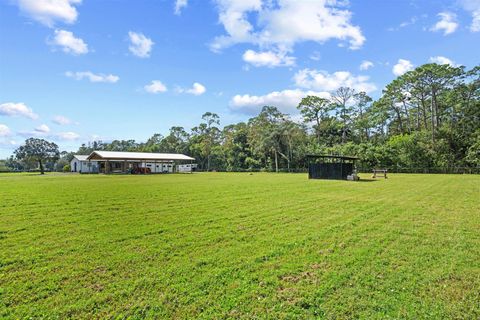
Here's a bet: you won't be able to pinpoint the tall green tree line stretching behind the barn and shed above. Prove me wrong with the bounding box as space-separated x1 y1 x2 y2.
6 63 480 172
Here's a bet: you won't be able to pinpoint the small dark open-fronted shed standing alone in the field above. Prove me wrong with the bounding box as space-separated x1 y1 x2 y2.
307 155 359 180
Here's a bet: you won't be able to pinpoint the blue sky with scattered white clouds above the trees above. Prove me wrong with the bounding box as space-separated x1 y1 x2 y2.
0 0 480 158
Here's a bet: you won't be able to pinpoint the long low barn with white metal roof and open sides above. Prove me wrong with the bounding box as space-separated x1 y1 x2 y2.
82 151 196 173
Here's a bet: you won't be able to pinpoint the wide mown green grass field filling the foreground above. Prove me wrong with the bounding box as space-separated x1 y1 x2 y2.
0 173 480 319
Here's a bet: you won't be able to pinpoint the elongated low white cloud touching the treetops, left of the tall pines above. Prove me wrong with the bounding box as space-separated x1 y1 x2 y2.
230 89 330 115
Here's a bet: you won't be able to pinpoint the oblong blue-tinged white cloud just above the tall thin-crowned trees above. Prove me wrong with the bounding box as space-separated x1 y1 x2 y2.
293 69 377 93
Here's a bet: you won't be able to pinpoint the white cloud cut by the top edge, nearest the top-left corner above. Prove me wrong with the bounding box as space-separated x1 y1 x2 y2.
17 0 82 27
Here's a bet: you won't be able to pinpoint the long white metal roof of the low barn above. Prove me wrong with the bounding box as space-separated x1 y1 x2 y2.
87 151 195 161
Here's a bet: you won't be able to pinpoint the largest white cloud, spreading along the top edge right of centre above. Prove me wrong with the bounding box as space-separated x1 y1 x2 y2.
211 0 365 51
